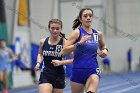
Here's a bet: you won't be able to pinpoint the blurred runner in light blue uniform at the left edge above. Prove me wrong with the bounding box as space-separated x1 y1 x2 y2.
0 39 16 93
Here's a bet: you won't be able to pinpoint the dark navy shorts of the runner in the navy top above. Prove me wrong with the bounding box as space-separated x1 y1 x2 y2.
39 72 65 89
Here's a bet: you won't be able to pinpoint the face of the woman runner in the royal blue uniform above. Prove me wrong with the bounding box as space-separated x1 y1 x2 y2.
80 10 93 27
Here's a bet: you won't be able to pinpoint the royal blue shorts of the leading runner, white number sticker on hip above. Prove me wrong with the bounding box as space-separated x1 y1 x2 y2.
70 68 101 84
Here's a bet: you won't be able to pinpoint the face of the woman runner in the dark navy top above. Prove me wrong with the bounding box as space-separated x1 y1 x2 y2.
50 23 62 37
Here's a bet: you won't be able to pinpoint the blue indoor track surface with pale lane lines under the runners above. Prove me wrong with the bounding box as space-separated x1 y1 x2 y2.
9 71 140 93
